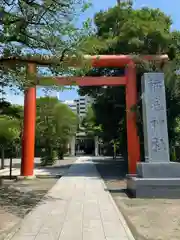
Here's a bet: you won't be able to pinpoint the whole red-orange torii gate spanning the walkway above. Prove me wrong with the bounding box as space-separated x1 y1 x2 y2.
21 55 168 177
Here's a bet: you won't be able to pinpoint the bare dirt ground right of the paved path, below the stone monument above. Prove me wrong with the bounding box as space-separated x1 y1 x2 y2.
94 159 180 240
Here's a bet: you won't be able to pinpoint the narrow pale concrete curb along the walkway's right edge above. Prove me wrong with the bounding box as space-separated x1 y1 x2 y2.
91 160 135 240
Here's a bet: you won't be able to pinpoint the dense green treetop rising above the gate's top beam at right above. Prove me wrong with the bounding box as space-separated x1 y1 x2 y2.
95 2 172 54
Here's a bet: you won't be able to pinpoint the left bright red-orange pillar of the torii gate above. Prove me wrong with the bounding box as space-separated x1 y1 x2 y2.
21 64 36 177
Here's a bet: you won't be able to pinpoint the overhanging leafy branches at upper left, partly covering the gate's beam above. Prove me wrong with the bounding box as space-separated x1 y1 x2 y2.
0 0 95 89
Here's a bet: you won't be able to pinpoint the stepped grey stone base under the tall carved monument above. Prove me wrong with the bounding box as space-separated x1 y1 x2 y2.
127 162 180 199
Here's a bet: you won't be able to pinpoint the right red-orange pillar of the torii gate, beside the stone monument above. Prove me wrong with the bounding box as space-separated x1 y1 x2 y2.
126 62 140 174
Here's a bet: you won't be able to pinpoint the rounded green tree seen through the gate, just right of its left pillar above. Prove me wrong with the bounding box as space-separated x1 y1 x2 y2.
36 97 78 165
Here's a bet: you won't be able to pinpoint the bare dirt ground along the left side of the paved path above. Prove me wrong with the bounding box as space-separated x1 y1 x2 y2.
0 158 75 240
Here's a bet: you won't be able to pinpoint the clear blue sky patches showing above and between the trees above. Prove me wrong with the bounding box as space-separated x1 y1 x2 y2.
7 0 180 104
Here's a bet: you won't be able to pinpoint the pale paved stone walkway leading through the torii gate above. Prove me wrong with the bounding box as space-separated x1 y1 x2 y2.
6 157 134 240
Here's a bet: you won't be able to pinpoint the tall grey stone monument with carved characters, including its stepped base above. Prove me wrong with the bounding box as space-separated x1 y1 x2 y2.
127 73 180 198
